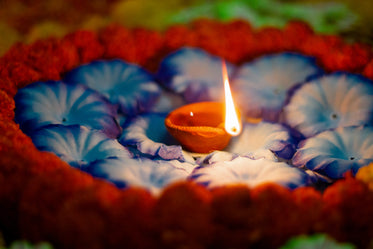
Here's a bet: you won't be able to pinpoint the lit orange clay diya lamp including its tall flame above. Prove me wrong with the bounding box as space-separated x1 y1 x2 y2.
165 62 242 153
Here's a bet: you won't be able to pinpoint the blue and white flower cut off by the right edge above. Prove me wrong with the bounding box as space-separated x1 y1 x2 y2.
293 126 373 179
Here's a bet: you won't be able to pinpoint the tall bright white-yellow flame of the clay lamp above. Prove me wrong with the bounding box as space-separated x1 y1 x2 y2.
222 61 241 136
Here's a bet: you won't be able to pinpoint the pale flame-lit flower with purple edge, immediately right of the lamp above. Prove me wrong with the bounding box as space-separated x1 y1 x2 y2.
226 121 296 161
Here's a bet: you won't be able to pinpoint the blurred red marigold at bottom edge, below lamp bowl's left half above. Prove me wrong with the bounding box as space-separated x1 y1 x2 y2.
154 182 212 248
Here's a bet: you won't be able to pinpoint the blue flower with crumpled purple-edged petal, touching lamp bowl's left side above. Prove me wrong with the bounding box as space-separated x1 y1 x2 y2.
119 113 187 161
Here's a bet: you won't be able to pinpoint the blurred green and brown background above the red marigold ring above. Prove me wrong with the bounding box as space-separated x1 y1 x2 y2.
0 0 373 55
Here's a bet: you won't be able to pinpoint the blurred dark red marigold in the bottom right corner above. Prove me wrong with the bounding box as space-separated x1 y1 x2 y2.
320 176 373 248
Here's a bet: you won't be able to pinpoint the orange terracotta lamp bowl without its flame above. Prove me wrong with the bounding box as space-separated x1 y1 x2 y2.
165 102 231 153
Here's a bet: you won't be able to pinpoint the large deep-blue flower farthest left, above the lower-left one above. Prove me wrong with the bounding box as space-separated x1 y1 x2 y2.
15 81 121 138
